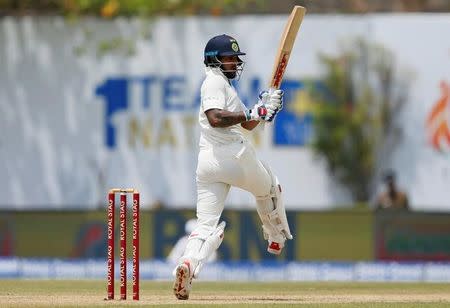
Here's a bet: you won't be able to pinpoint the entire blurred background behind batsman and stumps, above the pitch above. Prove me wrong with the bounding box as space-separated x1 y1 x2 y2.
0 0 450 281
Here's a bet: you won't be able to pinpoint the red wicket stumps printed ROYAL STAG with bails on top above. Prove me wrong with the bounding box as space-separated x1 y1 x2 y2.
106 188 139 300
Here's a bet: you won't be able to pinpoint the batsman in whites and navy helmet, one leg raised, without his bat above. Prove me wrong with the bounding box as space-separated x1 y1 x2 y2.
173 34 292 300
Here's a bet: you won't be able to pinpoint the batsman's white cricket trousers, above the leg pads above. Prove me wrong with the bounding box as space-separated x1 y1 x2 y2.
192 141 272 239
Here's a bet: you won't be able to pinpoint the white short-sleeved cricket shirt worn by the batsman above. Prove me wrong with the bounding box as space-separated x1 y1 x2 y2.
198 67 246 147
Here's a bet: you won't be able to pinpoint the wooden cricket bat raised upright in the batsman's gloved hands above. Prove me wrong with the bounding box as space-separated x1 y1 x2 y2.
269 5 306 91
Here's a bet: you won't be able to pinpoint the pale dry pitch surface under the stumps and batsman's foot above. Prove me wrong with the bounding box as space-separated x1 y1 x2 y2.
0 280 450 308
